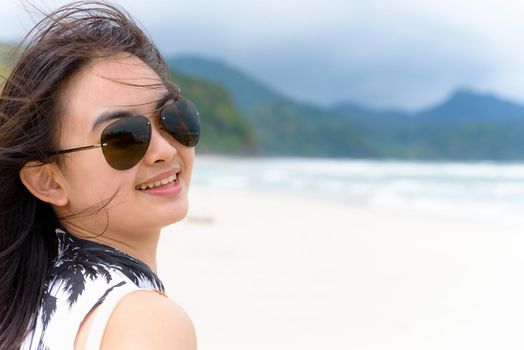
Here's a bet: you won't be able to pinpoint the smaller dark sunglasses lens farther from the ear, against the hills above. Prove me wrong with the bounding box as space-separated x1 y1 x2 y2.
160 100 200 147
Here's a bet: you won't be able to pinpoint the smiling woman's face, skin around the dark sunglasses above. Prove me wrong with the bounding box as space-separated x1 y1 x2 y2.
55 54 195 240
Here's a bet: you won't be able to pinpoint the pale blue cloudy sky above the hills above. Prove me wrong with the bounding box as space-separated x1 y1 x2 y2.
0 0 524 111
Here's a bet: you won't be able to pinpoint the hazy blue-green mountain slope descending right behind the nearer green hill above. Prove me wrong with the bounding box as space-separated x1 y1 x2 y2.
167 56 380 157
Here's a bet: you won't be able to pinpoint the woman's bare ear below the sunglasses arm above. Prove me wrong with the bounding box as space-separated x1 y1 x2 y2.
19 161 69 207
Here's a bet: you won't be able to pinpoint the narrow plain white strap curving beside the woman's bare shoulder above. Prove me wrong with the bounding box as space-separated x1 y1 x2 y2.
85 284 143 350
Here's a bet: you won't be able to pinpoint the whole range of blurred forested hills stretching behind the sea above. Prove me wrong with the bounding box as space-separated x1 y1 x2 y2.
0 44 524 160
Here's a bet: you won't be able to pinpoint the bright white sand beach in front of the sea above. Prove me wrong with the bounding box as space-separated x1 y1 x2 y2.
159 187 524 350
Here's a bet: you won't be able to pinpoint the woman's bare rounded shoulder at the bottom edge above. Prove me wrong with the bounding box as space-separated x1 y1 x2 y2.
101 291 196 350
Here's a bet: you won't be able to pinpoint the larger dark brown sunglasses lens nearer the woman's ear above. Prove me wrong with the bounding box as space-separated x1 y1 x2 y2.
101 116 151 170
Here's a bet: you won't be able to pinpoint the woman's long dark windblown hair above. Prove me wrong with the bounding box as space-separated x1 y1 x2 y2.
0 1 176 349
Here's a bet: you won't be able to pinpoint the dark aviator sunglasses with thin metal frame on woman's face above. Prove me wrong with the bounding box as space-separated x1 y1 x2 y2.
54 100 200 170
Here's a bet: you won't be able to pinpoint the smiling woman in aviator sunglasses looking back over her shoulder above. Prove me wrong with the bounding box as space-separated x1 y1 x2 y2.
0 2 199 349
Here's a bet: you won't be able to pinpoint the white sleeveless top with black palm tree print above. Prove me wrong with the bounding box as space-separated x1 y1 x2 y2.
21 229 164 350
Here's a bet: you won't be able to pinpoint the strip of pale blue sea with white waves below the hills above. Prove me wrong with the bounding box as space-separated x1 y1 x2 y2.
192 156 524 222
